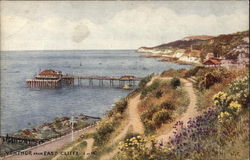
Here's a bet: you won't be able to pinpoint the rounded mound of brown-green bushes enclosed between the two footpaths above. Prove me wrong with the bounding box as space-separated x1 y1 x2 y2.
139 78 189 134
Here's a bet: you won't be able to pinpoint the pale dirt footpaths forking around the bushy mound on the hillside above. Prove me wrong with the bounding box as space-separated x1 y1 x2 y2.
100 76 198 160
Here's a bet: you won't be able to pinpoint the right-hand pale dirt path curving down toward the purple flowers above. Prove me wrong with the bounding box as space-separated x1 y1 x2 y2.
157 78 198 144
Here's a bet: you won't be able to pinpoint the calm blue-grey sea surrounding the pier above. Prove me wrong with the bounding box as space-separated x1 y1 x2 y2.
1 50 189 134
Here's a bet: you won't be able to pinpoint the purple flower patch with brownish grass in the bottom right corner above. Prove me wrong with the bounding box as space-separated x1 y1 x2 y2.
168 109 249 159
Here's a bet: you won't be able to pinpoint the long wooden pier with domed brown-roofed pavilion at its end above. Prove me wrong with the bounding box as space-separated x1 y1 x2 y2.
26 70 143 88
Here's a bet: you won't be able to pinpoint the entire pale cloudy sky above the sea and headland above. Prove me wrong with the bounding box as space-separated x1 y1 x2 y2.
0 1 249 50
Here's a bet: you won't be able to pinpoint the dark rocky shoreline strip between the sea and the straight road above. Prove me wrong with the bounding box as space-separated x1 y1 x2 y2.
0 114 101 156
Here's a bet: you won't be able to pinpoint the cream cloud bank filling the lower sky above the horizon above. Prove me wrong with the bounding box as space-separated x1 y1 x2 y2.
1 5 248 50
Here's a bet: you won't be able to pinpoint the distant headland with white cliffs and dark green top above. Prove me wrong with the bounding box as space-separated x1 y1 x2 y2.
138 31 249 62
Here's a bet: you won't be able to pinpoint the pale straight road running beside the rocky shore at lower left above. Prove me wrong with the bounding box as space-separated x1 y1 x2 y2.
3 126 95 160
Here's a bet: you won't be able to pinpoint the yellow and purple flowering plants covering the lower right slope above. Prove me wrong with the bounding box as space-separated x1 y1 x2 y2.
114 70 250 160
